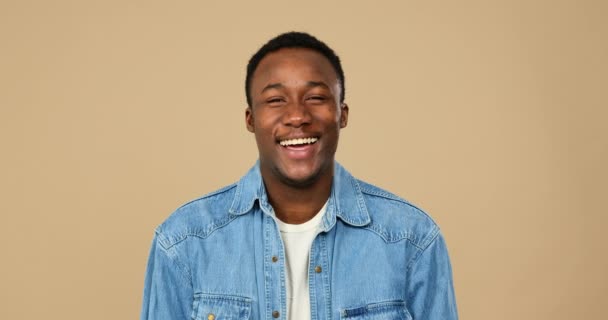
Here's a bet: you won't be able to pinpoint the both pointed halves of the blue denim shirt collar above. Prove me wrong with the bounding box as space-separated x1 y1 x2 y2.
229 161 371 231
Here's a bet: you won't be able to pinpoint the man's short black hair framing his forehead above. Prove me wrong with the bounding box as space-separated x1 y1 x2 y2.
245 31 345 107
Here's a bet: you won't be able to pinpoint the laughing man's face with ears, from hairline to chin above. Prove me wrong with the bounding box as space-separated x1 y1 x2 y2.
245 48 348 187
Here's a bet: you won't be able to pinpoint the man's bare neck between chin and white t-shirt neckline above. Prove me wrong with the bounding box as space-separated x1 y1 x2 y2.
262 166 333 224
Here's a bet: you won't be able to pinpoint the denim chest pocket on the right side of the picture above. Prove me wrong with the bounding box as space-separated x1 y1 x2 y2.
340 300 412 320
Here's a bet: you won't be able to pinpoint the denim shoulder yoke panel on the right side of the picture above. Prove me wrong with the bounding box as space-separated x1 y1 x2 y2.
357 180 439 250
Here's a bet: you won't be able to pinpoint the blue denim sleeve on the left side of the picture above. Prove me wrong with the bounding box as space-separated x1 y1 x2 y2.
141 232 193 320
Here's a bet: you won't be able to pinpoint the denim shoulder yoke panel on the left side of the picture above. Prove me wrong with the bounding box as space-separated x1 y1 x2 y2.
156 184 236 248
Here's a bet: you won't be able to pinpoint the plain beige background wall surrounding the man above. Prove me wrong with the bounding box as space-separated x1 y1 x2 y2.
0 0 608 320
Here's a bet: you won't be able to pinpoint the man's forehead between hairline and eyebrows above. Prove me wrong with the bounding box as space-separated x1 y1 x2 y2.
251 48 338 91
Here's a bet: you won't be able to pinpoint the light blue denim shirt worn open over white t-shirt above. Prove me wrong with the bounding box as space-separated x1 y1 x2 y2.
141 163 458 320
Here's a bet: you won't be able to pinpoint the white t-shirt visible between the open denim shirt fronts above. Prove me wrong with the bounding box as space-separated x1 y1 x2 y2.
276 202 327 320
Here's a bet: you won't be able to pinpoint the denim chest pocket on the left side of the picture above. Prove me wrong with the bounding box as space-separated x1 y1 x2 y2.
192 293 251 320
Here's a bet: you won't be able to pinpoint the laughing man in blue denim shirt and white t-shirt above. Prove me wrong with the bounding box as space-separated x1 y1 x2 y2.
141 32 458 320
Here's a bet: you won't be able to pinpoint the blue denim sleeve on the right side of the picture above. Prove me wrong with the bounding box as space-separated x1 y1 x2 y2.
407 232 458 320
